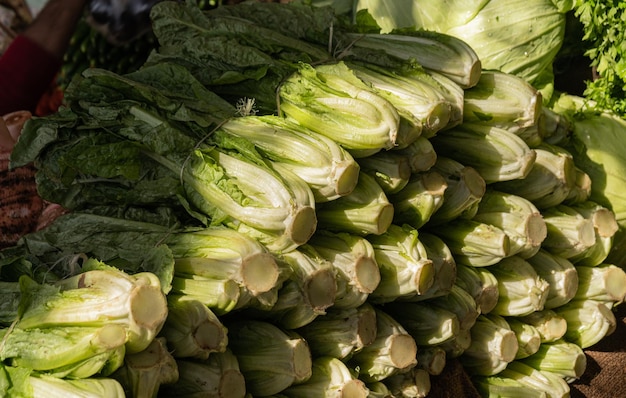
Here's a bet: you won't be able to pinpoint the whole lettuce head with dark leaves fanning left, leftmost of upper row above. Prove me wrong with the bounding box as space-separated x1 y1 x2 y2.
12 63 316 251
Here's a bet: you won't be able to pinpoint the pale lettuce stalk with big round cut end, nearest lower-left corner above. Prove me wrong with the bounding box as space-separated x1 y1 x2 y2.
16 260 167 352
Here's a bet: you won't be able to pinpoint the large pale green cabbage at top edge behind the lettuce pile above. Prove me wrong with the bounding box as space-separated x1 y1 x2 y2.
356 0 573 83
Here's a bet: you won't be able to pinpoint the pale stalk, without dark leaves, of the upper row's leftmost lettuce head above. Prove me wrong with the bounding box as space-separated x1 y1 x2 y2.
138 119 316 251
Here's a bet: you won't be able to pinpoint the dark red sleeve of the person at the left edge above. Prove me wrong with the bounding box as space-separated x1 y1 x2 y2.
0 36 62 115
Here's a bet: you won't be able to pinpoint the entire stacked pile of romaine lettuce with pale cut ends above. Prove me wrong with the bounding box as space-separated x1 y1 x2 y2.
0 1 626 398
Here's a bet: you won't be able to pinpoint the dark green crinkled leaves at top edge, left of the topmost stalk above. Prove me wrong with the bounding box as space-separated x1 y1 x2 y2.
147 2 328 85
